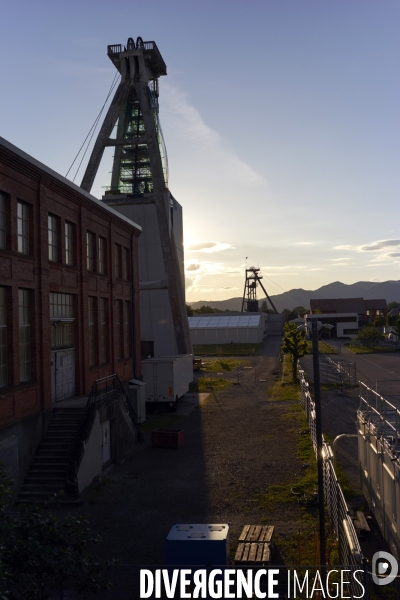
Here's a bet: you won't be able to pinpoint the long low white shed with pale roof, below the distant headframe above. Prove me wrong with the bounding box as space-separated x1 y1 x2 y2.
189 313 265 344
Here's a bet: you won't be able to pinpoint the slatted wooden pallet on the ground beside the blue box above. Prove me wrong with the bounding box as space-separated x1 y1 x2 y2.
235 525 274 565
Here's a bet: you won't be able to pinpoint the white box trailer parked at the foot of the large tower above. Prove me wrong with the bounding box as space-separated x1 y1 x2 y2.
142 354 193 410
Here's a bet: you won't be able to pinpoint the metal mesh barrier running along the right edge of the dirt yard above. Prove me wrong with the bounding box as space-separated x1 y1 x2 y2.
299 368 367 597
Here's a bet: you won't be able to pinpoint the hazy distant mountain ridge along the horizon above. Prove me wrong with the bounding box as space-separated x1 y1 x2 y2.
191 281 400 312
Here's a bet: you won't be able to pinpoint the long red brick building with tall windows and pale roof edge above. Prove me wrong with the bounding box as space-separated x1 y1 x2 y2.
0 138 141 492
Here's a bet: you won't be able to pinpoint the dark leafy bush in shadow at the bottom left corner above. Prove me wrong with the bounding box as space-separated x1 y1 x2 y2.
0 463 116 600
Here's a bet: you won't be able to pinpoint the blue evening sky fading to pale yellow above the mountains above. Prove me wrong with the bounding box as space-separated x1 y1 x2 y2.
0 0 400 303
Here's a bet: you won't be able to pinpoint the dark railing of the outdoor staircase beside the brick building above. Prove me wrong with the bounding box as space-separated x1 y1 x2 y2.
65 374 137 494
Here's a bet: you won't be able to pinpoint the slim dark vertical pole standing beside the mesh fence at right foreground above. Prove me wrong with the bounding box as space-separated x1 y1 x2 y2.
312 319 326 588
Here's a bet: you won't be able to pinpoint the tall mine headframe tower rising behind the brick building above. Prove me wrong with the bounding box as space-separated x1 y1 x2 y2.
81 37 192 356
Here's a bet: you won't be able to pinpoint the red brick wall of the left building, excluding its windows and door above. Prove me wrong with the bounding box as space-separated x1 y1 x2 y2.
0 145 141 437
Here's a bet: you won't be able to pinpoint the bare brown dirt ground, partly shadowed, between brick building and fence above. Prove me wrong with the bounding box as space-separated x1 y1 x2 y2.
72 338 324 599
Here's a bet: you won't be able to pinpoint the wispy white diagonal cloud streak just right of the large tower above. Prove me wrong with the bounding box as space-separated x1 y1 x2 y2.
162 82 265 186
